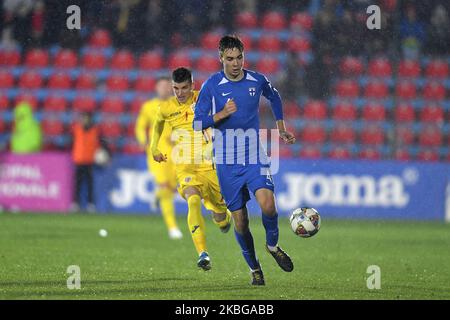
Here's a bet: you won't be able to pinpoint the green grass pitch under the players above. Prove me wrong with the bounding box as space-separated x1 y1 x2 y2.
0 213 450 300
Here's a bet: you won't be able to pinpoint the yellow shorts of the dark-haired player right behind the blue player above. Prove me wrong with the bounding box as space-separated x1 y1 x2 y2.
177 167 227 213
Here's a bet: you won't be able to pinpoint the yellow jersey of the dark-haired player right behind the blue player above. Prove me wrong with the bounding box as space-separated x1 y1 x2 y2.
157 91 213 170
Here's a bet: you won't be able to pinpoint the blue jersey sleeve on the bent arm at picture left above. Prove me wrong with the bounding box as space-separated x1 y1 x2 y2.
192 81 214 131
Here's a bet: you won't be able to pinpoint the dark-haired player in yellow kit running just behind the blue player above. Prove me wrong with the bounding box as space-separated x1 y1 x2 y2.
151 67 231 270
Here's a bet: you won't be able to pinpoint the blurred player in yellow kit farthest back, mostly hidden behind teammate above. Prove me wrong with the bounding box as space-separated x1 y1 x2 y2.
135 77 183 239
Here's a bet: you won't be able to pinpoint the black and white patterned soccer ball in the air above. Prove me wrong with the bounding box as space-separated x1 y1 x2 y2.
289 207 320 238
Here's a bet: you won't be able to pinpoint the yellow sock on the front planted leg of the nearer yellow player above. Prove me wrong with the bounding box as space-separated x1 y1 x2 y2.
187 194 207 254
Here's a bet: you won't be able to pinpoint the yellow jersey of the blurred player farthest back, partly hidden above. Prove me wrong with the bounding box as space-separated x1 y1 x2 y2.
135 98 172 156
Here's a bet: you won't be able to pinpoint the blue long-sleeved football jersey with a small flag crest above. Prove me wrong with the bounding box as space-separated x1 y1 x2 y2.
193 69 283 164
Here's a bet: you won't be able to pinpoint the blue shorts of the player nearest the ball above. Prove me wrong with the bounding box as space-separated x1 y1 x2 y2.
216 164 274 211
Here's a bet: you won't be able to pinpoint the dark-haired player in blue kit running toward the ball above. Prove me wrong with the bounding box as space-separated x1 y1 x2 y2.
194 36 295 285
